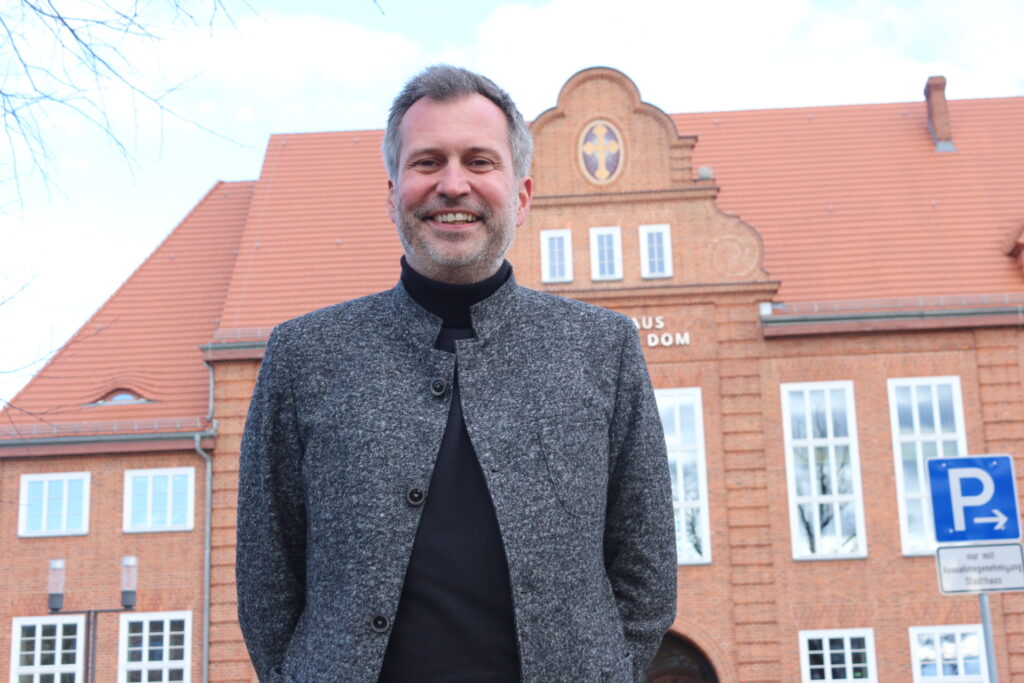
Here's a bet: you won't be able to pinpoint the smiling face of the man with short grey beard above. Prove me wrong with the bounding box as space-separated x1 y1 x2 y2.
387 94 532 284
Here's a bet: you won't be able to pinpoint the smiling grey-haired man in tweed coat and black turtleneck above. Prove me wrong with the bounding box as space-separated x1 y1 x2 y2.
237 67 676 683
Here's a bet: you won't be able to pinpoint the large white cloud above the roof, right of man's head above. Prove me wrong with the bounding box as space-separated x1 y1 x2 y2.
467 0 1024 117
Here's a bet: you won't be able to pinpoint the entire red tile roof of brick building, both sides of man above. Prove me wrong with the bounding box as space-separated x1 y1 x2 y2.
0 82 1024 440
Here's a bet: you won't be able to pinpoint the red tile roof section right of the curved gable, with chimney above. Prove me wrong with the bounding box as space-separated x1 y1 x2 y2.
673 97 1024 302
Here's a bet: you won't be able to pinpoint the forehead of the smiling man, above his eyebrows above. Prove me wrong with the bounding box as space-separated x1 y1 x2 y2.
401 93 511 156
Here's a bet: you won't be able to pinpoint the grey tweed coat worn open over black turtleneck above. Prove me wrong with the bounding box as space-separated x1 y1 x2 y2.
237 279 676 683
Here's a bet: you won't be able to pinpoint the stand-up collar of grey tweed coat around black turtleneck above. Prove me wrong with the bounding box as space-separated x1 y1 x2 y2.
388 272 522 347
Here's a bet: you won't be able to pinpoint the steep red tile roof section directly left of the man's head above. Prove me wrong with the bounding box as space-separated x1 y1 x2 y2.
216 130 401 339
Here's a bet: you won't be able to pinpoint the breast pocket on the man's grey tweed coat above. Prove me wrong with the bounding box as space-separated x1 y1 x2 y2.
541 421 608 518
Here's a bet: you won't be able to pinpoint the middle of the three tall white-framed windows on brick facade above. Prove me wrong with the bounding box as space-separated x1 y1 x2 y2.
782 382 867 559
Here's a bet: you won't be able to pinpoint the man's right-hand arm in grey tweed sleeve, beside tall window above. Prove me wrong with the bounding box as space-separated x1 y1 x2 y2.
604 326 676 679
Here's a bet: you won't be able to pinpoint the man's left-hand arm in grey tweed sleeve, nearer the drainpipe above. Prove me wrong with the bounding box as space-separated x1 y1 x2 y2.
236 330 306 681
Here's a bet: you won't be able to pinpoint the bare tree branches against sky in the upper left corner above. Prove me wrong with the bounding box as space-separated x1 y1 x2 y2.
0 0 245 197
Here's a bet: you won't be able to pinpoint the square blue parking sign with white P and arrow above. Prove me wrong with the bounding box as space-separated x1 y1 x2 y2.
928 455 1021 543
